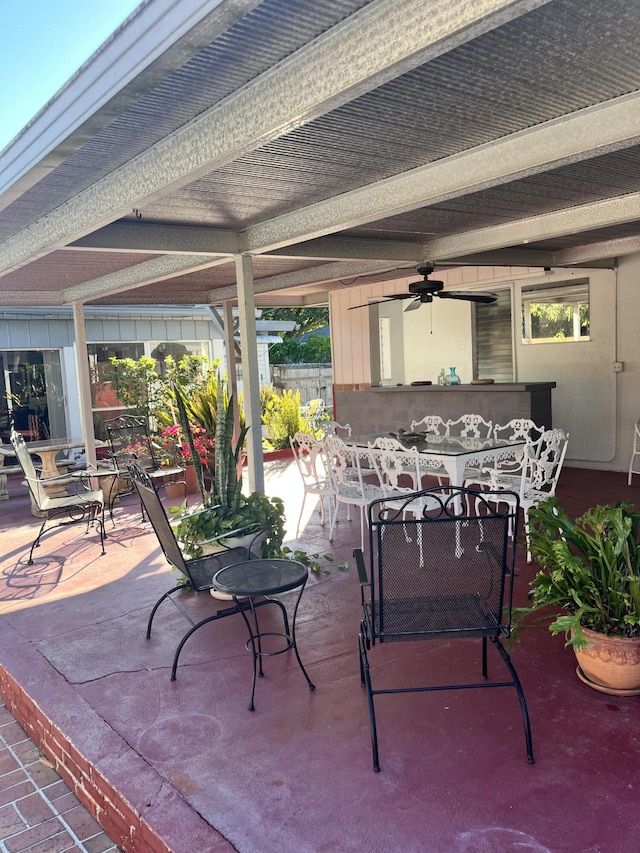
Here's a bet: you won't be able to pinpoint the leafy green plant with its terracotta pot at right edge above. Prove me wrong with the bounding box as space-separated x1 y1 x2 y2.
514 498 640 695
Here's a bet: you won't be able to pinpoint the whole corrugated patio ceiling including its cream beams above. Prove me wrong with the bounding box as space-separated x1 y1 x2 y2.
0 0 640 304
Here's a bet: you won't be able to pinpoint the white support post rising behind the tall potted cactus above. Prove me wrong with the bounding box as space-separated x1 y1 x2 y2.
236 255 264 494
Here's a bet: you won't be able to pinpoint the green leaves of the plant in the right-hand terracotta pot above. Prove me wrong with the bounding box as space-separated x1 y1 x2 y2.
514 498 640 649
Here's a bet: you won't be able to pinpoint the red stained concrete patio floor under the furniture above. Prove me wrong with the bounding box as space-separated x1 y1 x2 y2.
0 461 640 853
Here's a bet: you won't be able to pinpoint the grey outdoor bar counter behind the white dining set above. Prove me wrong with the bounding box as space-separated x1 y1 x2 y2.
334 382 556 435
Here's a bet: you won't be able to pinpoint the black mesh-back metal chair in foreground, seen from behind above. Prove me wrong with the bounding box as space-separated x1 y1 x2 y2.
354 486 533 772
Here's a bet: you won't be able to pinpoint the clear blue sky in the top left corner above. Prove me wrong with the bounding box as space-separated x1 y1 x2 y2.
0 0 140 151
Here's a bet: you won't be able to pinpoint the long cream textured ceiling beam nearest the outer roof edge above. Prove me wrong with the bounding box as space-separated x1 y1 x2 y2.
0 0 536 280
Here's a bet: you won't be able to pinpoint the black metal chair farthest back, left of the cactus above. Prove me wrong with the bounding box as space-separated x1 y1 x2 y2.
104 415 187 506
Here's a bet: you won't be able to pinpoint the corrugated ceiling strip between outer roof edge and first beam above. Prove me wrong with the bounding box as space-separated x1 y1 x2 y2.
0 0 367 239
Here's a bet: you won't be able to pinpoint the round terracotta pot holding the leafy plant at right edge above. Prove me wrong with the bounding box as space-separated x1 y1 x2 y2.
575 628 640 696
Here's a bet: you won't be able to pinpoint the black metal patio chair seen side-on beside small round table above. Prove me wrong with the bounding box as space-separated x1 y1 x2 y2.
129 463 282 681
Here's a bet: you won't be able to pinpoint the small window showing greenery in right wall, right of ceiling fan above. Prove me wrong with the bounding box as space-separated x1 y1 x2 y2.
522 279 590 344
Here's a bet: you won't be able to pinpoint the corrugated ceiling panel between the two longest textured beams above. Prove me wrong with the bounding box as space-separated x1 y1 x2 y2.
120 2 640 236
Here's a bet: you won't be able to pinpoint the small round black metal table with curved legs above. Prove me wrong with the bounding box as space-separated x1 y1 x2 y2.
213 559 315 711
